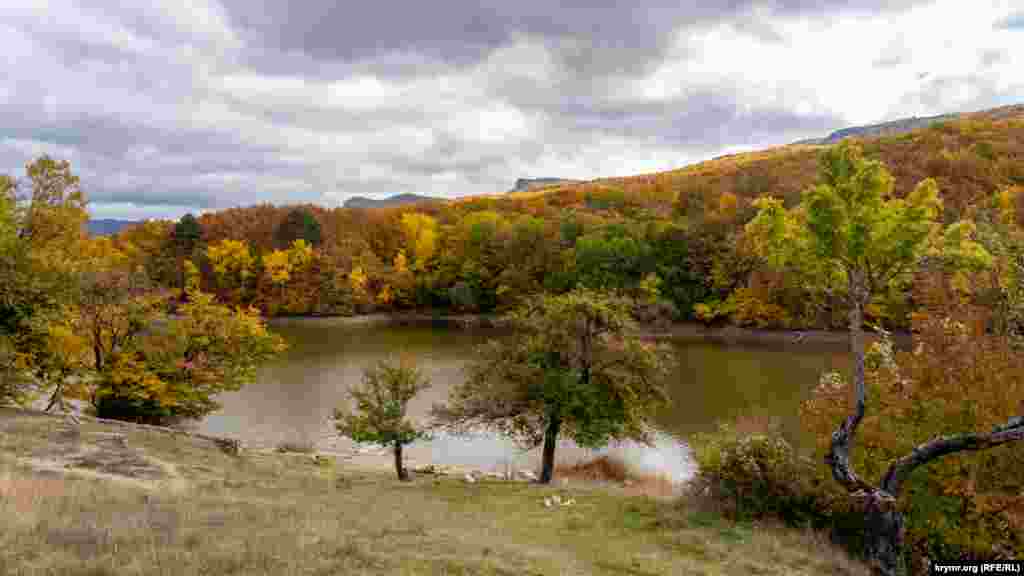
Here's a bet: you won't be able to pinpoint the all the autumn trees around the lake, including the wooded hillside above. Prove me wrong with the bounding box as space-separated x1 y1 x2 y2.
0 106 1024 574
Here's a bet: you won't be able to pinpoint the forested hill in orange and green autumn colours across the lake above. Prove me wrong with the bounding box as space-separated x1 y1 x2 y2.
110 106 1024 327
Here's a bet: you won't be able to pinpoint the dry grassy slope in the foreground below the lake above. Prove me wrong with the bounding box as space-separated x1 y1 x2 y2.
0 409 866 576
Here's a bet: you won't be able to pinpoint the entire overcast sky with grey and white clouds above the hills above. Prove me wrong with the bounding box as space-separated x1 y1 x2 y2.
0 0 1024 218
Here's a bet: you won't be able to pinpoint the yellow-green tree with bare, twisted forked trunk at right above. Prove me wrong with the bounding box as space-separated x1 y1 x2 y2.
746 142 999 574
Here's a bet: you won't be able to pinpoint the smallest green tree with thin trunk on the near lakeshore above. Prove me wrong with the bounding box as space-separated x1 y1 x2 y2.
334 358 430 481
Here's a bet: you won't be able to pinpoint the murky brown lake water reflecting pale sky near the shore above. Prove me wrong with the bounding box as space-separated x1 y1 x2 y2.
195 319 848 481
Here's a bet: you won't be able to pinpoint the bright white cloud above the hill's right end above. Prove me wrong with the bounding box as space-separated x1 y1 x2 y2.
634 0 1024 124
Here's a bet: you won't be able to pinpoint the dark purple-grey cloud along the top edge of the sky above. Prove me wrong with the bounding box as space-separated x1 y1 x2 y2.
224 0 924 81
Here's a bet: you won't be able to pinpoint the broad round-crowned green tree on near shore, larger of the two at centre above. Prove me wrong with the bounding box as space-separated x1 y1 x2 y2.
433 288 670 483
